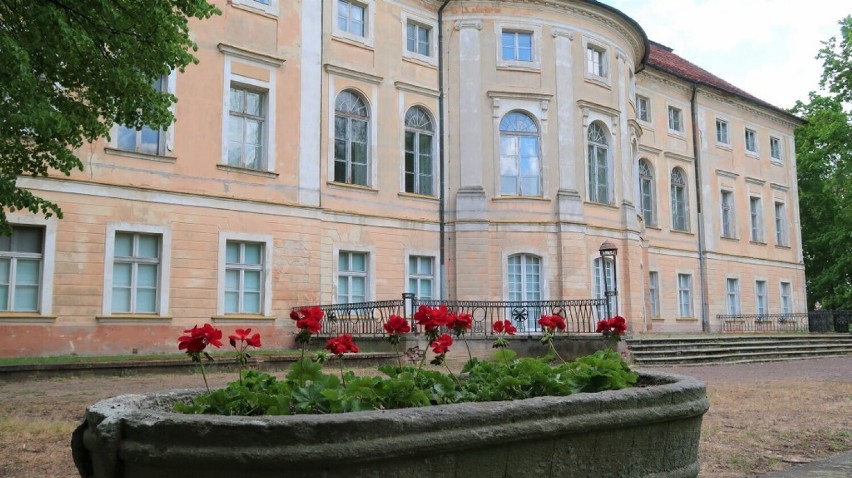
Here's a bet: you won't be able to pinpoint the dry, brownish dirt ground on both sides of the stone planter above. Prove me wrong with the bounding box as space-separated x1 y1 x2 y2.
0 357 852 478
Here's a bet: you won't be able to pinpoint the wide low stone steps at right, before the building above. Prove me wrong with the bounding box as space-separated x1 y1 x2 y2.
626 334 852 366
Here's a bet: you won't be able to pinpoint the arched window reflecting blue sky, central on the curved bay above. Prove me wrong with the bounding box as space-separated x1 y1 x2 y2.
500 111 541 196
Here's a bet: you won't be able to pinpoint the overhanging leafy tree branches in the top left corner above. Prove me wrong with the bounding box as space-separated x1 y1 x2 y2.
0 0 220 234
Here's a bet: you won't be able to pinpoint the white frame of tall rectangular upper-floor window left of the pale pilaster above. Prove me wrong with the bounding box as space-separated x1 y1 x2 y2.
220 53 278 173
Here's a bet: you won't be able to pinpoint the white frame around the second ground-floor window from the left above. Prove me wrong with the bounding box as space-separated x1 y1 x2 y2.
102 222 172 317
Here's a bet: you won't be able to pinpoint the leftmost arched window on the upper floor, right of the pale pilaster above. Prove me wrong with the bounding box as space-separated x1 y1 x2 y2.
334 90 370 186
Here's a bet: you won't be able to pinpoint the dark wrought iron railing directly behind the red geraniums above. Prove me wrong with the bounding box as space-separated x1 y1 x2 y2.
295 294 606 337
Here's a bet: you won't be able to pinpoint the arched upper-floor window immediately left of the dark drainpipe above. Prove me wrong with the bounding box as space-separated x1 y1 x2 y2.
405 106 435 196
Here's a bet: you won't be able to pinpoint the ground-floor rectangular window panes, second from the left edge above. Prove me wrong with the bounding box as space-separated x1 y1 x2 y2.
112 232 162 314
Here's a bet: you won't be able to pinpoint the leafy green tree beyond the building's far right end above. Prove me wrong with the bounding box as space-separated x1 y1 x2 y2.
793 16 852 309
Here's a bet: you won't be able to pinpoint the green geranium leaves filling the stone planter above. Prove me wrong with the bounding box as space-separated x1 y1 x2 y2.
175 350 638 415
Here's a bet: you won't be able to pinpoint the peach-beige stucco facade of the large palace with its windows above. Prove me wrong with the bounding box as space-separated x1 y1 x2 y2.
0 0 806 355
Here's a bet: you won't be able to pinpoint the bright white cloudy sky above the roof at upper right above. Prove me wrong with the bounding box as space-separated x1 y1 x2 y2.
602 0 852 108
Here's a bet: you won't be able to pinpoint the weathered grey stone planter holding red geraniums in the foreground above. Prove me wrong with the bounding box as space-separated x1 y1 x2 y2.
72 373 708 478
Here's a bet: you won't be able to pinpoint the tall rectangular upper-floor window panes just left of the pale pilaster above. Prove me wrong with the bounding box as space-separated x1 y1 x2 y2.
228 85 266 169
